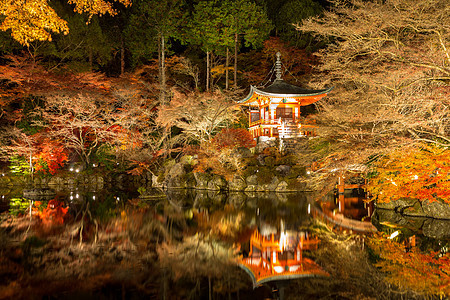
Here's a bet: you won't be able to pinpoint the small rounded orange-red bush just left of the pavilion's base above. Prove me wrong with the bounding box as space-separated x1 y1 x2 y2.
212 128 256 149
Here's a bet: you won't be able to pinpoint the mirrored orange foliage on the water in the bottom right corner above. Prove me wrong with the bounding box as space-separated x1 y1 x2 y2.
368 235 450 297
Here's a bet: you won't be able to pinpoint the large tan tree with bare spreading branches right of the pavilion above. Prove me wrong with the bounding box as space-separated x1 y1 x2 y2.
298 0 450 165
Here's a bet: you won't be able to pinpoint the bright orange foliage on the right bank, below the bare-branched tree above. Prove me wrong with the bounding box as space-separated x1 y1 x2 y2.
368 145 450 204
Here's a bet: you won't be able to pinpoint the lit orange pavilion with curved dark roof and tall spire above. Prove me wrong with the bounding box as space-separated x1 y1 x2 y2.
238 52 332 138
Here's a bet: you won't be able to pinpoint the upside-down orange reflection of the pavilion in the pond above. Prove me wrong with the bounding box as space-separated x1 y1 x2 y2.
240 223 329 287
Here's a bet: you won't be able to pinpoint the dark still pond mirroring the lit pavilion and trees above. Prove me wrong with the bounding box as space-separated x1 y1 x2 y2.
0 188 450 299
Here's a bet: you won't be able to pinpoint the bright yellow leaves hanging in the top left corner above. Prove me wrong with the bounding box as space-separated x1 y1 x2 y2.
0 0 131 46
